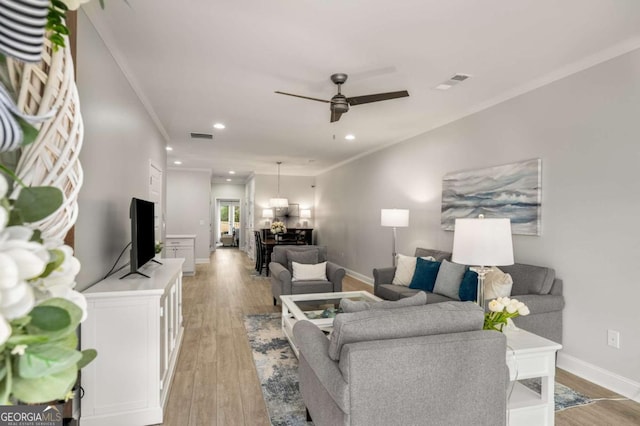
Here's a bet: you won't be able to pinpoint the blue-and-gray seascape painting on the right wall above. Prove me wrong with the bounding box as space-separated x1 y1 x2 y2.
441 158 542 235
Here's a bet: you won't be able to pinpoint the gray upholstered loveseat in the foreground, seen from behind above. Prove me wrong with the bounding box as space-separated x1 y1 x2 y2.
293 302 508 426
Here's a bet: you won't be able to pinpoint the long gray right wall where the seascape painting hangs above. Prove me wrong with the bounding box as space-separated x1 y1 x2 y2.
316 51 640 390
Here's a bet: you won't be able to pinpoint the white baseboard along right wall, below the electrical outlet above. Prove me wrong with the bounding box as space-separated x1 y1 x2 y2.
557 352 640 402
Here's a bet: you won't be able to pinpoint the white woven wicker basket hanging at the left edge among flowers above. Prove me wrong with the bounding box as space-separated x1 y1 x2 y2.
8 35 84 240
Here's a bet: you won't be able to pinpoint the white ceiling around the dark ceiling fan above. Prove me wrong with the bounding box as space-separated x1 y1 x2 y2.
83 0 640 181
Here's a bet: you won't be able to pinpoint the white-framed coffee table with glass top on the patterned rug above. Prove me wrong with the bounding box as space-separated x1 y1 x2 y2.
280 291 382 356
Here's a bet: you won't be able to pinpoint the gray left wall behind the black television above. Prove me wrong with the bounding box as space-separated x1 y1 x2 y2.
75 11 166 290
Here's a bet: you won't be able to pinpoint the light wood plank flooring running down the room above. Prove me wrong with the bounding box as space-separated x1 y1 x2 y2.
163 247 640 426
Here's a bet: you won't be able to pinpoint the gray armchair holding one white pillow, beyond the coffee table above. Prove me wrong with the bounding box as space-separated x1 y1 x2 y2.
269 245 345 305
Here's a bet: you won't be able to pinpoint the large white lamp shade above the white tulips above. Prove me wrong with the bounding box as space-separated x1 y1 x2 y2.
451 218 513 266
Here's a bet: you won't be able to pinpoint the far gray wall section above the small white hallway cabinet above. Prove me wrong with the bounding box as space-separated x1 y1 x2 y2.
167 169 211 263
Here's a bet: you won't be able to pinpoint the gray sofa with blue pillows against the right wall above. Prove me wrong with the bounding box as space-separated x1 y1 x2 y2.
373 248 564 343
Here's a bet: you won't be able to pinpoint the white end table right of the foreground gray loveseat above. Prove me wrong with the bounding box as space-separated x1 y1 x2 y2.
504 329 562 426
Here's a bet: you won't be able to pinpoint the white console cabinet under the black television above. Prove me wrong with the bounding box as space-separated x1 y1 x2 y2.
80 259 184 426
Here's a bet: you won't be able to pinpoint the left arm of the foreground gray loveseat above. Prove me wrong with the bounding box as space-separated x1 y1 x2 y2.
293 321 349 413
